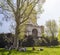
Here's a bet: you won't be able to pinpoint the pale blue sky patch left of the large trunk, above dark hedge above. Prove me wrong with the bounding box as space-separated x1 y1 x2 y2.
0 14 11 33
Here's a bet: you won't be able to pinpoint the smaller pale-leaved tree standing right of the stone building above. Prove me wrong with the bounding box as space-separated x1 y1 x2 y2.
46 20 58 38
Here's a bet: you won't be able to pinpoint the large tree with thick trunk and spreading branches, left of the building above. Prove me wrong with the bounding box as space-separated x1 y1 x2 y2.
0 0 45 49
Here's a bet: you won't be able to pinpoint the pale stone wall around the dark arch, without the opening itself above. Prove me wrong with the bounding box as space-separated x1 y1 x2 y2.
26 24 44 36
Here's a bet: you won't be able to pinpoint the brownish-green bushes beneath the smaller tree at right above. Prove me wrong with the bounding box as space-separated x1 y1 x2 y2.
37 36 59 46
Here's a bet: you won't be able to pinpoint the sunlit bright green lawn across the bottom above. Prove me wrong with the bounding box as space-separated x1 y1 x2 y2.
0 47 60 55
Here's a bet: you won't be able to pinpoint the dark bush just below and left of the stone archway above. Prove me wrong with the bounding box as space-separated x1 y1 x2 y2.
22 35 35 47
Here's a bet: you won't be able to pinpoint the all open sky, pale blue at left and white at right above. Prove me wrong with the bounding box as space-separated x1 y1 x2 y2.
0 0 60 33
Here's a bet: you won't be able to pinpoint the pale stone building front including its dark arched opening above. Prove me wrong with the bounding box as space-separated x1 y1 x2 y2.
26 24 44 36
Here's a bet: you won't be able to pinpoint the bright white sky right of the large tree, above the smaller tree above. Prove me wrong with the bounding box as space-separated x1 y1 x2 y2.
37 0 60 25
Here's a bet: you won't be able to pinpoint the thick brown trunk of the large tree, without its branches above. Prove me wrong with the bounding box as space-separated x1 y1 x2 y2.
14 15 20 49
